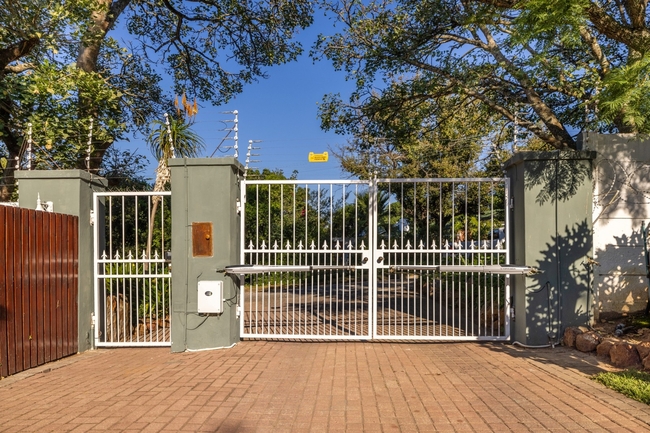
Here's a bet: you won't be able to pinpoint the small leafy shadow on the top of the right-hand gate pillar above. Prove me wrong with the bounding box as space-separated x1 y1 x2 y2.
524 151 591 205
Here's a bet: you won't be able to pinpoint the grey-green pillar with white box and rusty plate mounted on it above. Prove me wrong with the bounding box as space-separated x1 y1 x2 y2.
169 157 243 352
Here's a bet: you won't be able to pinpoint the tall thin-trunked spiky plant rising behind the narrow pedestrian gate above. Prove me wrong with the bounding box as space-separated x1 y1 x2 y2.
147 95 205 258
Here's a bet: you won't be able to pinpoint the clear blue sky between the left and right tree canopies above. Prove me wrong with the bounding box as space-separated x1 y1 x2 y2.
118 13 353 180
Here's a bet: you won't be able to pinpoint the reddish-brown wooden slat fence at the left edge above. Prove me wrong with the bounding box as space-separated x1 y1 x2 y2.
0 206 79 377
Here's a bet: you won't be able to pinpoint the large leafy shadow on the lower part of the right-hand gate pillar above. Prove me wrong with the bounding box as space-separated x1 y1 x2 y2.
526 220 593 341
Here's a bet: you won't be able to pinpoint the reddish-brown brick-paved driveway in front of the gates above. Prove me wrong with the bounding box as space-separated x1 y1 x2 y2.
0 341 650 433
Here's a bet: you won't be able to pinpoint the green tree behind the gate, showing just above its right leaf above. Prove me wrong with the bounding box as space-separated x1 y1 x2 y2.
321 93 512 179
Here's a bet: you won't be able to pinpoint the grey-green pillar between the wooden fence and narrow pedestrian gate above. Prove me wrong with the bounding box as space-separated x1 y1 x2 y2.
15 170 108 352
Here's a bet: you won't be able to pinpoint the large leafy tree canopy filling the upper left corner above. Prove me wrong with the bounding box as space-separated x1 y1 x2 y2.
0 0 312 199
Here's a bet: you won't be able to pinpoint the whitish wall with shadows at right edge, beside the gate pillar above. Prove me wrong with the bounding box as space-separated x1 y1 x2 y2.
582 133 650 320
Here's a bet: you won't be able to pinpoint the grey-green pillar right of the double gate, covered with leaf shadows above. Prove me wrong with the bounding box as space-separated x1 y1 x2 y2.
506 151 596 345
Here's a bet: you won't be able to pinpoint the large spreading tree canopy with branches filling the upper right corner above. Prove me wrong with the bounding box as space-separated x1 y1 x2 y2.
313 0 650 154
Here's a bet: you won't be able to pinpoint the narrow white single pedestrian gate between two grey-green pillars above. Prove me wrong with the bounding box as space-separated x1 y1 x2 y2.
93 192 171 347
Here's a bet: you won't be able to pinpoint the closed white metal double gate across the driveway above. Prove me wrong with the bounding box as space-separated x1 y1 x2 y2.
235 179 525 340
